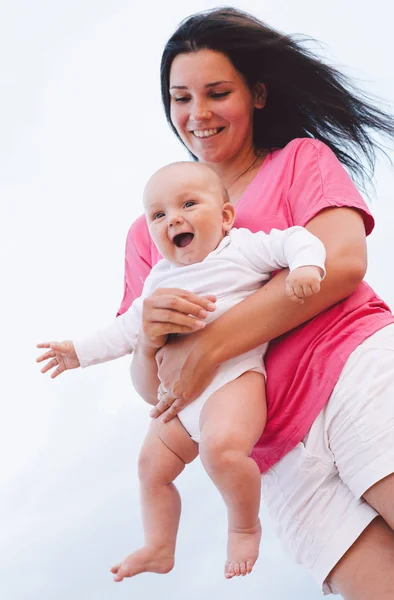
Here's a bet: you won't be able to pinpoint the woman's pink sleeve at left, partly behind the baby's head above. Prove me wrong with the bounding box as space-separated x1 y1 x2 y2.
117 215 152 316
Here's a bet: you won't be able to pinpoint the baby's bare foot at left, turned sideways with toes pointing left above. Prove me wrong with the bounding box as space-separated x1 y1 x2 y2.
111 546 174 581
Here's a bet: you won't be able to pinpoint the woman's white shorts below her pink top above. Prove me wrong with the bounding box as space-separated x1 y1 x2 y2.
262 324 394 594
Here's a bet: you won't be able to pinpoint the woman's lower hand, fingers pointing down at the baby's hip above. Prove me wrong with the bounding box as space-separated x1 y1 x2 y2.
150 329 218 423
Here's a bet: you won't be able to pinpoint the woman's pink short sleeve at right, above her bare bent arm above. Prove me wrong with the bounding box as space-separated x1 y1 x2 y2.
287 139 374 235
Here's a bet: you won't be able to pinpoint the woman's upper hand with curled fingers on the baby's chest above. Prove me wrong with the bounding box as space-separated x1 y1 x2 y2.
141 288 216 348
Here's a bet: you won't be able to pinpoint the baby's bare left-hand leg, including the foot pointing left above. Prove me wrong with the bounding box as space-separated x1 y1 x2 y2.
111 418 198 581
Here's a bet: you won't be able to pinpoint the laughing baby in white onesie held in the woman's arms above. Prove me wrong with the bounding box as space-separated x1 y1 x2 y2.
37 163 325 581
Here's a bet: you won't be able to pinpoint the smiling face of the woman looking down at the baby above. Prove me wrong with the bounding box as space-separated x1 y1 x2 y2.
170 50 261 163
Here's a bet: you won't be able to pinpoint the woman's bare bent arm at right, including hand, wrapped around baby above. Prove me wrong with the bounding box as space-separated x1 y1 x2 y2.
152 207 367 420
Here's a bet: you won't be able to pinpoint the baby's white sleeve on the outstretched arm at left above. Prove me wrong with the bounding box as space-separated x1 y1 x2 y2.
73 297 143 368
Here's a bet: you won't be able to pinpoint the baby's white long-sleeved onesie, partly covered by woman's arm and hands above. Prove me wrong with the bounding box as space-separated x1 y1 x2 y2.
74 227 325 442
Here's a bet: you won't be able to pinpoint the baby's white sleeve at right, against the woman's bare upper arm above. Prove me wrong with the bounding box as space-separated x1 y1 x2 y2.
239 226 326 277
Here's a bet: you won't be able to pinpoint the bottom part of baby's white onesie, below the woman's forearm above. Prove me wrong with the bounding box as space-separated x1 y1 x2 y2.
178 344 267 443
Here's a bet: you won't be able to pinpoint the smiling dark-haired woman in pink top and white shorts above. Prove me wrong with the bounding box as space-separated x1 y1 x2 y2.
120 9 394 600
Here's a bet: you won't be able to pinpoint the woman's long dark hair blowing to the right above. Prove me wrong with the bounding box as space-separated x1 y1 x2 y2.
161 7 394 182
